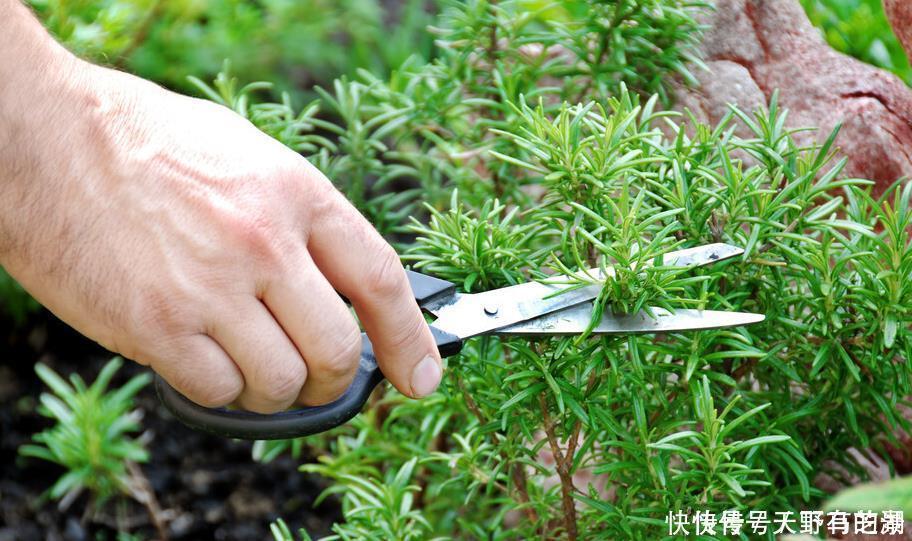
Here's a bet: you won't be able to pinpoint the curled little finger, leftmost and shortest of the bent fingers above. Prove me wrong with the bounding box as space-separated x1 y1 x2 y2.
137 334 244 408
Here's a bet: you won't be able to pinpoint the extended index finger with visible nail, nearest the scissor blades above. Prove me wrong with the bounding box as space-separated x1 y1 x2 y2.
308 185 442 398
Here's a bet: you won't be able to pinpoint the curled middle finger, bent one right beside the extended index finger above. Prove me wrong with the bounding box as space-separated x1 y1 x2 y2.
263 253 361 406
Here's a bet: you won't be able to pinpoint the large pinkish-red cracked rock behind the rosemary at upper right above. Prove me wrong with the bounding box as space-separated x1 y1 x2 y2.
676 0 912 193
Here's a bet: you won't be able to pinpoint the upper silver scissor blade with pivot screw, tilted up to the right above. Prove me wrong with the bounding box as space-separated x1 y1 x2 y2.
422 243 743 339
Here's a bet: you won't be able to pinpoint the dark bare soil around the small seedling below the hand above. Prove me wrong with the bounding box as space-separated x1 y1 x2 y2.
0 312 341 541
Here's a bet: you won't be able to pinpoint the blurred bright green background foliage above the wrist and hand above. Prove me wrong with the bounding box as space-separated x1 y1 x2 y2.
30 0 431 95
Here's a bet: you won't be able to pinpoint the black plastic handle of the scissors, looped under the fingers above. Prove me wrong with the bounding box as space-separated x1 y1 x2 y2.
155 271 462 440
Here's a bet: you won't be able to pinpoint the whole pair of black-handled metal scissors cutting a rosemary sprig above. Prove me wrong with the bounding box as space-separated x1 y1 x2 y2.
155 243 764 440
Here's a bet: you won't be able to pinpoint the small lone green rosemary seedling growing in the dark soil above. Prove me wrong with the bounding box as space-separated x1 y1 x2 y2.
19 358 150 505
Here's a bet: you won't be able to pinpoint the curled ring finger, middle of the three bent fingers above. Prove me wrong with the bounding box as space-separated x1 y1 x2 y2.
210 296 307 413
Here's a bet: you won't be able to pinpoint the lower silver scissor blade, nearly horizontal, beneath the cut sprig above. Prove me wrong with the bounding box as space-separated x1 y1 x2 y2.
497 302 764 335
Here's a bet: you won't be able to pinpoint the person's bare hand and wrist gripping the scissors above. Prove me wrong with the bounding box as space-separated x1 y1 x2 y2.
0 0 441 413
